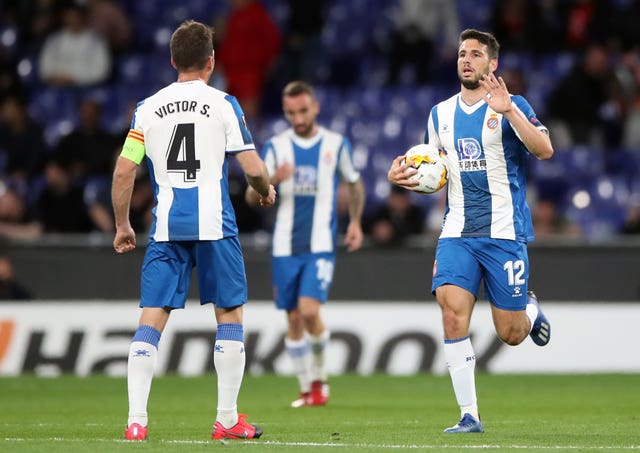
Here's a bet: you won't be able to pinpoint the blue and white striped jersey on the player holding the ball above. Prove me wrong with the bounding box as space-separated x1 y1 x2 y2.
425 93 546 242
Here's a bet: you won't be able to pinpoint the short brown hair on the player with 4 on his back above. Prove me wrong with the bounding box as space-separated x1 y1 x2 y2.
169 20 214 71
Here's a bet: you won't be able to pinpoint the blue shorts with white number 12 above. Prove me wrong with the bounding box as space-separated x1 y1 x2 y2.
431 238 529 310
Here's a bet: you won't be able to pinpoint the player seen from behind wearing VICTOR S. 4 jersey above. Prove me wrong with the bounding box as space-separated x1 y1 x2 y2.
112 21 276 440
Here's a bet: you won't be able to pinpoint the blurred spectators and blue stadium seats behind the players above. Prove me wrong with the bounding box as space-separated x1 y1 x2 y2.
0 0 640 251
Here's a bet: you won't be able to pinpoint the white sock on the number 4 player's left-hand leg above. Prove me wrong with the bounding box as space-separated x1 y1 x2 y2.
127 341 158 426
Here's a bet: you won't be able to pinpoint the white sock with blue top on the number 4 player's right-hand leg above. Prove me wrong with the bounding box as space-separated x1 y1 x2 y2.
213 324 245 428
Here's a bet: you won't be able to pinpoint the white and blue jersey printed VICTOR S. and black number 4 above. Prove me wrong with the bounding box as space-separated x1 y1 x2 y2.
122 80 255 242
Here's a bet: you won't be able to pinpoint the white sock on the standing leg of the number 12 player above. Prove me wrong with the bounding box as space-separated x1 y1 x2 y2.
444 337 479 420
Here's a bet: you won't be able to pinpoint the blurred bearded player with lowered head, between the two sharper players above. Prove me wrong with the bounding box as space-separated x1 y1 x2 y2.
245 81 365 407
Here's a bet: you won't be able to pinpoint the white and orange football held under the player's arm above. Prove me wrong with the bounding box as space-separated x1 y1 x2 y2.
404 143 447 194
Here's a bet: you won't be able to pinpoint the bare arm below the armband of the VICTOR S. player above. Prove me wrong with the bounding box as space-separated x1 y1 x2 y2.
111 156 138 253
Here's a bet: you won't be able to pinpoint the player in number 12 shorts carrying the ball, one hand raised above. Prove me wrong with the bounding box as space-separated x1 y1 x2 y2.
388 29 553 433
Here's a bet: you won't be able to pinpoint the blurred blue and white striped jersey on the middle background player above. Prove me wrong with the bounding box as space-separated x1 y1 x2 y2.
262 127 360 256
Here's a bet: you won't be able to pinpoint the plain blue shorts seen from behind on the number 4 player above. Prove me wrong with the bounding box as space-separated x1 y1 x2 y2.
140 237 247 308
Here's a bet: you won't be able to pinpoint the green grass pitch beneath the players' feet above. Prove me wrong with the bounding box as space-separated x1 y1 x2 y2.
0 374 640 453
